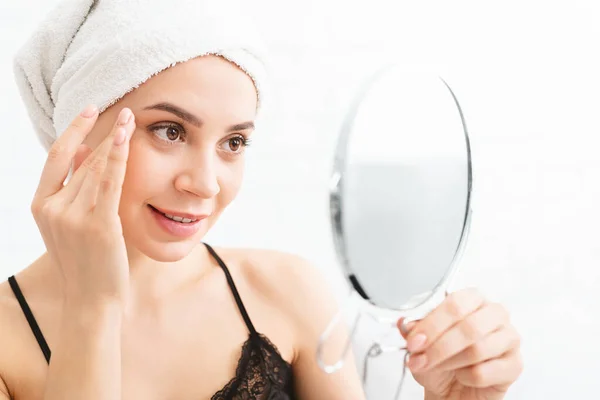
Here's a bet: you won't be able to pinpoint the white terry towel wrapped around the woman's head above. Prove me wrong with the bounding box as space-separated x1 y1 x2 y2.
15 0 266 149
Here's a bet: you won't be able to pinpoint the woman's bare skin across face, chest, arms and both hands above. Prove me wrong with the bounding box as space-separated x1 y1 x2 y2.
0 56 522 400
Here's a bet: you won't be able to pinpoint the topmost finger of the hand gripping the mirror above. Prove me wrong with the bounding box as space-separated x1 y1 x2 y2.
407 289 485 353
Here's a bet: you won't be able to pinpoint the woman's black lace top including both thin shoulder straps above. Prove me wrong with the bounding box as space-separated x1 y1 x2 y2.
8 243 295 400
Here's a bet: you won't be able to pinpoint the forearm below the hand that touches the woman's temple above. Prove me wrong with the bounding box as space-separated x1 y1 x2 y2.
44 304 122 400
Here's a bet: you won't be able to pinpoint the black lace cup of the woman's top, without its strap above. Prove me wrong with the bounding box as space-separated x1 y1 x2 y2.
211 334 292 400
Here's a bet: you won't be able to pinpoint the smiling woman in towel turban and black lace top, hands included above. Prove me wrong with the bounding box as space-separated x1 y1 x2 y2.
0 0 521 400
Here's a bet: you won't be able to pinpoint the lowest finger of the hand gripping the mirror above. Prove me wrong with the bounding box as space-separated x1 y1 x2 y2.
455 351 523 391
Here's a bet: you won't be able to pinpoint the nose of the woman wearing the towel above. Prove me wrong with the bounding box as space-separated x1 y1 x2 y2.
175 154 221 199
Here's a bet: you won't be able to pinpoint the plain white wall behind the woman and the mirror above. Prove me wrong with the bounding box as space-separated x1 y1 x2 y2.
0 0 600 400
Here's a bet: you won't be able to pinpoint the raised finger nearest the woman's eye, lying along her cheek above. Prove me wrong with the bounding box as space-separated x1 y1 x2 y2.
94 114 135 218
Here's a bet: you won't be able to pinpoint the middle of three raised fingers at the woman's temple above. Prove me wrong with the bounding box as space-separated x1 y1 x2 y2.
73 108 133 212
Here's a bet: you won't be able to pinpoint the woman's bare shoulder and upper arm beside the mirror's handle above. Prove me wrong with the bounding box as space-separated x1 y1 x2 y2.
211 249 364 399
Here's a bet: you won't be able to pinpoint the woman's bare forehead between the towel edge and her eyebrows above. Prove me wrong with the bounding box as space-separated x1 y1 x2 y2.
127 55 258 120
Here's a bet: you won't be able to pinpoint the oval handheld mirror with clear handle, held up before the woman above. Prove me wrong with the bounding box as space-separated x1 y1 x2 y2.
317 66 472 396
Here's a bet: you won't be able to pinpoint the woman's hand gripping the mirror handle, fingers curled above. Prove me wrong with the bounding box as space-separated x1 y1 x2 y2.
398 289 523 400
